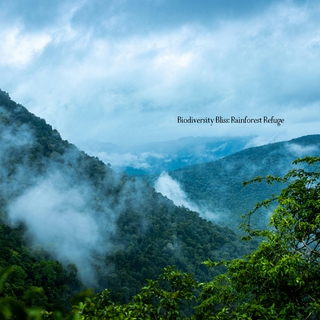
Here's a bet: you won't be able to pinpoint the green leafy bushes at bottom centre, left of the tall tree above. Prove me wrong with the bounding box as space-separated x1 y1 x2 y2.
80 267 197 320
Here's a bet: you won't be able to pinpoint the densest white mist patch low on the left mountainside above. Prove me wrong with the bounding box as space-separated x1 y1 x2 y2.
8 171 114 286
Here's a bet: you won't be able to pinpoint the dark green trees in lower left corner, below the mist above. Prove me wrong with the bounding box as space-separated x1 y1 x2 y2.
0 223 83 311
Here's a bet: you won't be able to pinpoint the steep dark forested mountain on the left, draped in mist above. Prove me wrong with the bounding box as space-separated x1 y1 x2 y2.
0 91 254 309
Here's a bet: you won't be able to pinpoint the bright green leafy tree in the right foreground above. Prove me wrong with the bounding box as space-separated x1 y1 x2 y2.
196 157 320 319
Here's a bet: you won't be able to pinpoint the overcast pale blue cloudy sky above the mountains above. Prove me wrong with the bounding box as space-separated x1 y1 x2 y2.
0 0 320 150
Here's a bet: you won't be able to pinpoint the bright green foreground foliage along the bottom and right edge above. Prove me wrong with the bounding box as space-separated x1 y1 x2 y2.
0 157 320 320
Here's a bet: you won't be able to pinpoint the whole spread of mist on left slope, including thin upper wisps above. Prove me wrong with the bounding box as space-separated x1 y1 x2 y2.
0 118 117 287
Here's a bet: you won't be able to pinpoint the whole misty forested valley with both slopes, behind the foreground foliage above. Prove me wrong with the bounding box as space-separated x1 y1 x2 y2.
0 91 320 317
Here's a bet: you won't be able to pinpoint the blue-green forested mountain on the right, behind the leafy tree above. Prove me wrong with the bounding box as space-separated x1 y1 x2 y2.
162 135 320 230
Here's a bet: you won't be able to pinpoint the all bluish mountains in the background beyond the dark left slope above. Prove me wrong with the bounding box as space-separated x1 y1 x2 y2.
81 122 320 230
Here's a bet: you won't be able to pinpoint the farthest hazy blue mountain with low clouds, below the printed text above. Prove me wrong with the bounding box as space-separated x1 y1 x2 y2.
81 137 250 175
